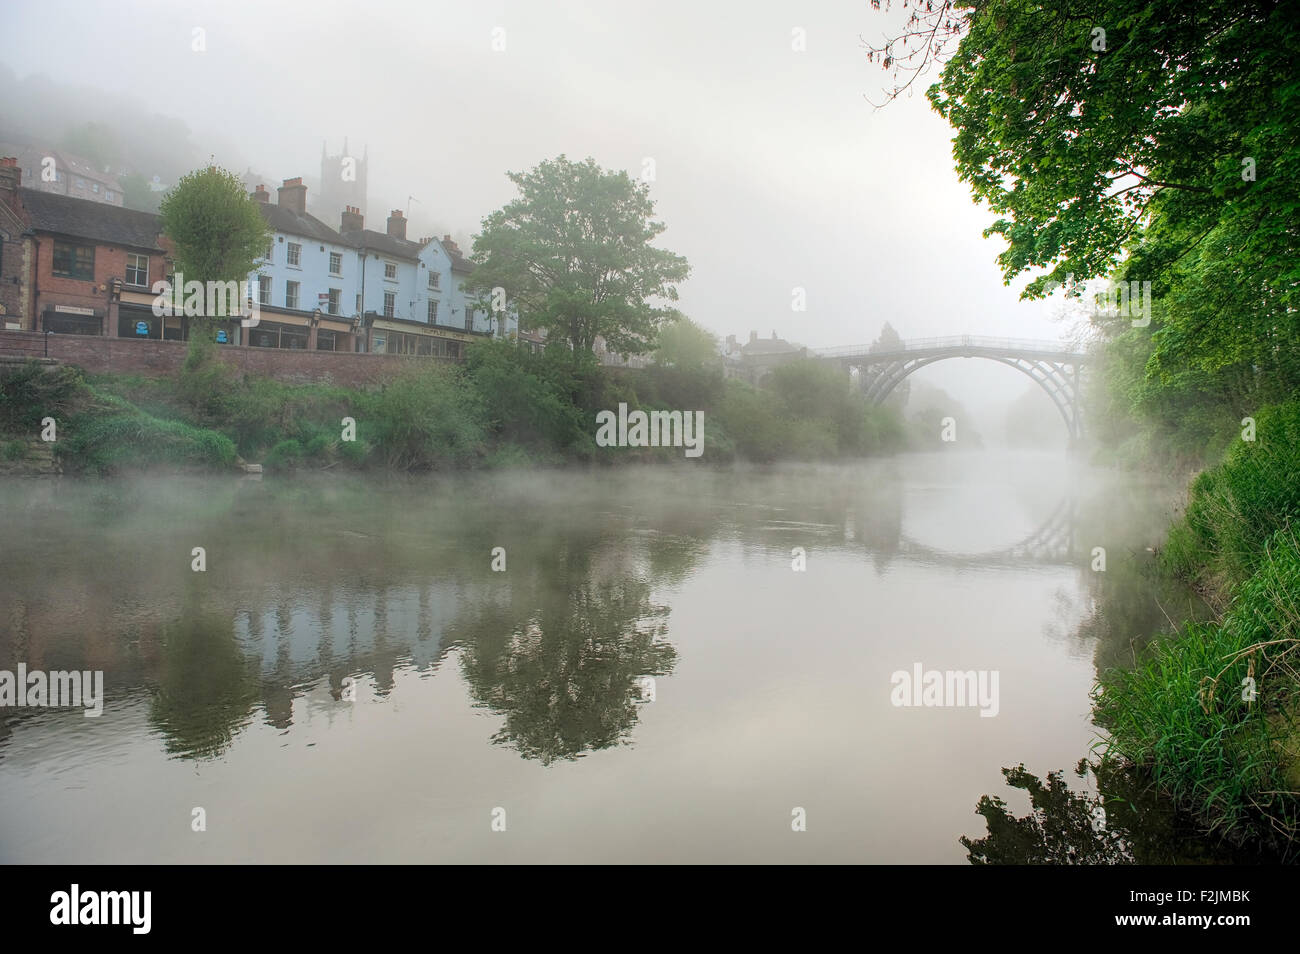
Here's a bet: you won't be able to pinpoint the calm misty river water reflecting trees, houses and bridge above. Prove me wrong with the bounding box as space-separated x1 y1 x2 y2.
0 452 1216 863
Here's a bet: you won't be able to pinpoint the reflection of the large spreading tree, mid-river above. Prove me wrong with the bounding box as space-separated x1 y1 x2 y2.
460 542 677 764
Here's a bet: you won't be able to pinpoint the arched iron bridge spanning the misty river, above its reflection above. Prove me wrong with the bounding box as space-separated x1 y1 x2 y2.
816 335 1086 441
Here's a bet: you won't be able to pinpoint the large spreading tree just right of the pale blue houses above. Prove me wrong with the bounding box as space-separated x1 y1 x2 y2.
471 156 690 355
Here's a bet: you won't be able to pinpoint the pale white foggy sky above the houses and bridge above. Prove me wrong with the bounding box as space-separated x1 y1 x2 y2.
0 0 1066 418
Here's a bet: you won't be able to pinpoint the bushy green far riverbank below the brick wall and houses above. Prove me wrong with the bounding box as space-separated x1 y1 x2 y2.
0 342 904 474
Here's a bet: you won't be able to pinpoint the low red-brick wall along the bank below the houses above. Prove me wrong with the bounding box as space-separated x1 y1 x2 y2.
0 331 457 387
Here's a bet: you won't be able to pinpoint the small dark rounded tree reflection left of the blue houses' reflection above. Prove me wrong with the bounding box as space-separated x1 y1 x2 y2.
150 610 260 759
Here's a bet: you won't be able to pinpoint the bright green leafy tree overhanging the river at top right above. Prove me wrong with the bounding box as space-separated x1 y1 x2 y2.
928 0 1300 455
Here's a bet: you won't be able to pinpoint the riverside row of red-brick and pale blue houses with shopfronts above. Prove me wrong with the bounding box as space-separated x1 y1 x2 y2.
0 159 541 360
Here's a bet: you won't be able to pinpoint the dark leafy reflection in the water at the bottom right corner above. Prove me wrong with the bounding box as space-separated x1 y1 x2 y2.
961 760 1260 864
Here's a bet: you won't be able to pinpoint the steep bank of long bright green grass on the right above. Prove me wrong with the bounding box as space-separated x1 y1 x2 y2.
1095 403 1300 855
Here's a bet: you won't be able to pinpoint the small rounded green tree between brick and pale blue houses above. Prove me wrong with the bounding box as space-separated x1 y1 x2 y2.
159 165 270 295
